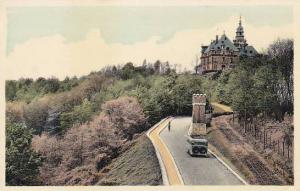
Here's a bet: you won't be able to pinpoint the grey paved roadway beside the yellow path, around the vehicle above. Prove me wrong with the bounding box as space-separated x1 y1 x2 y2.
160 117 243 185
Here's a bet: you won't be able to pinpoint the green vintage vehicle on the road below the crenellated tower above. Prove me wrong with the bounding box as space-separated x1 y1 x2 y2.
187 136 208 157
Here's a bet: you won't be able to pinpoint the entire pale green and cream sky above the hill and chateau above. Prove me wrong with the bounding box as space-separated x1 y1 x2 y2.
5 5 293 79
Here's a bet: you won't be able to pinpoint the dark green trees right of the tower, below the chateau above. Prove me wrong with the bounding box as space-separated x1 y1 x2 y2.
213 39 293 120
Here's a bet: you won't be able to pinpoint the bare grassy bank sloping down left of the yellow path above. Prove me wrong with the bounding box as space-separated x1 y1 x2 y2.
97 134 162 185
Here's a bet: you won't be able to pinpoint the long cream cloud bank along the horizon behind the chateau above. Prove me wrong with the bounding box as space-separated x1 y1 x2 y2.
5 17 293 79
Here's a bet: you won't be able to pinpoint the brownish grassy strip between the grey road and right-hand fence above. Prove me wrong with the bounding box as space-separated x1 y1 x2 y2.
207 104 287 185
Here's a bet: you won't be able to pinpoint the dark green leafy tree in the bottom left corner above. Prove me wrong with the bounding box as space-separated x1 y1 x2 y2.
5 123 42 185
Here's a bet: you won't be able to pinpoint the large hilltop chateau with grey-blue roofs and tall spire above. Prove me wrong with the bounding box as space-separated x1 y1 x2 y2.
197 17 258 74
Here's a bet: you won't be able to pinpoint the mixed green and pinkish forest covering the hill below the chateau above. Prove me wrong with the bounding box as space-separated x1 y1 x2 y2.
5 39 294 185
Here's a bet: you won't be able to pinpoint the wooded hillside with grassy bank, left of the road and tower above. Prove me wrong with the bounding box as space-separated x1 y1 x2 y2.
6 63 206 185
